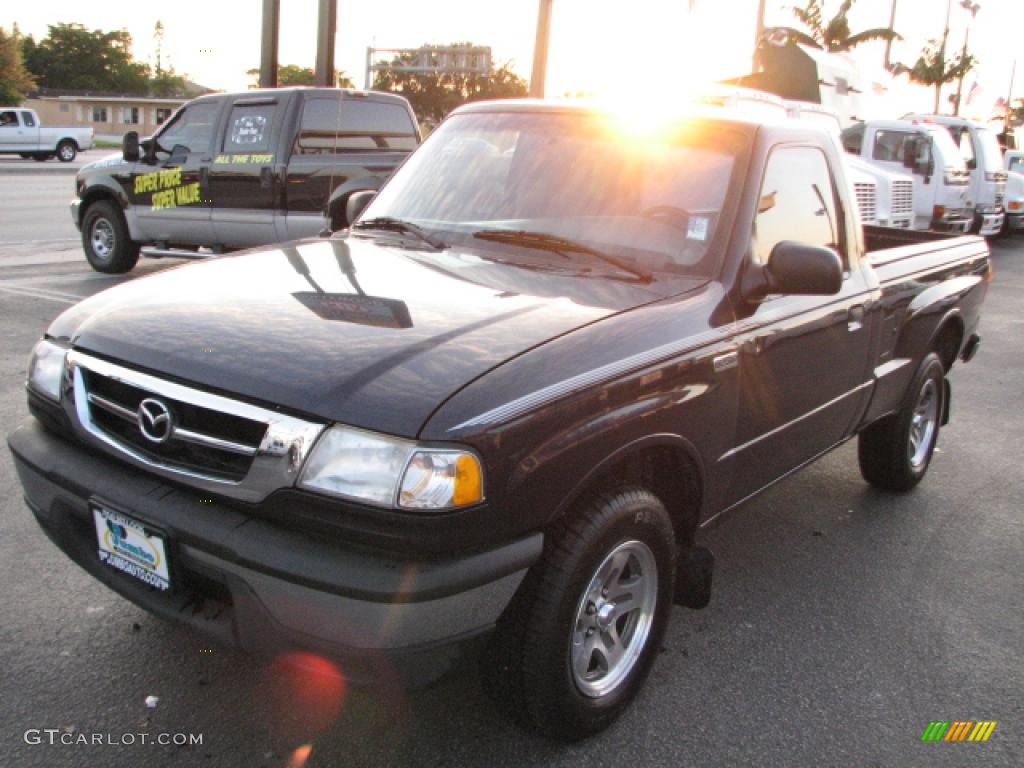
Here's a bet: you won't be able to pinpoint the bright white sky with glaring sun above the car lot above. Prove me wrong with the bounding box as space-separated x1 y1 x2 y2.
8 0 1024 117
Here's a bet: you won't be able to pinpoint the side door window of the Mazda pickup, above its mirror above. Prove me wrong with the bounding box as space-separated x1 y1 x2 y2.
752 146 846 266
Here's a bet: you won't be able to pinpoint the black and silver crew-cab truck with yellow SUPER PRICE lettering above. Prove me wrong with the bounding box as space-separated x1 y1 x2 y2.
72 88 420 272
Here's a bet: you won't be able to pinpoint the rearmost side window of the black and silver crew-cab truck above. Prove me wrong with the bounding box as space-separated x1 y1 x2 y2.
295 97 417 155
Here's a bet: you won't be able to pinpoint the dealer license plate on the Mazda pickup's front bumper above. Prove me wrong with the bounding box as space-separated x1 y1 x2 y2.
92 504 171 590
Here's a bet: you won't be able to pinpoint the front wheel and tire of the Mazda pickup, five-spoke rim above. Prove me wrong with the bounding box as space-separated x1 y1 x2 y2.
483 487 675 741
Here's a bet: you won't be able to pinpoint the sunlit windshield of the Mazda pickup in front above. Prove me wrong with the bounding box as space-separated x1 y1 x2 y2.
360 112 742 276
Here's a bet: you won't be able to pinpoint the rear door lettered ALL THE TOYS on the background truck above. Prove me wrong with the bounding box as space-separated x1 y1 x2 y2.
210 96 286 248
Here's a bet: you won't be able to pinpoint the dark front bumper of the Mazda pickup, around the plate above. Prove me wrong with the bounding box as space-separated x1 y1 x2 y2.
8 421 543 681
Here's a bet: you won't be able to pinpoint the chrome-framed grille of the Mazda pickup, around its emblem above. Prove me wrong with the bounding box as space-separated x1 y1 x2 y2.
63 350 324 502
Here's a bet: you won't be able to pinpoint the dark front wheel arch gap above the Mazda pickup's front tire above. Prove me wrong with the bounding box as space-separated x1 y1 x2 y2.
552 433 705 545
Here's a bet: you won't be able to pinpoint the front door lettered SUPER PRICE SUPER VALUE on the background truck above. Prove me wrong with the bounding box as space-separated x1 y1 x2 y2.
129 98 223 246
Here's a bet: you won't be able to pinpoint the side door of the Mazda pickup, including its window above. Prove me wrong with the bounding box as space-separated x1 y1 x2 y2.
723 145 876 501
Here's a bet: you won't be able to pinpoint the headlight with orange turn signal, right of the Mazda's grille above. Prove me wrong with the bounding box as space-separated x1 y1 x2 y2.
299 425 483 510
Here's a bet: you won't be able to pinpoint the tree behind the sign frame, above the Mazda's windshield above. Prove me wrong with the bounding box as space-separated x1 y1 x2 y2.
374 43 528 123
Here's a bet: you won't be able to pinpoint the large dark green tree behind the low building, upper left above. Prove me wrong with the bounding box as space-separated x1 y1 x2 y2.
23 24 150 95
